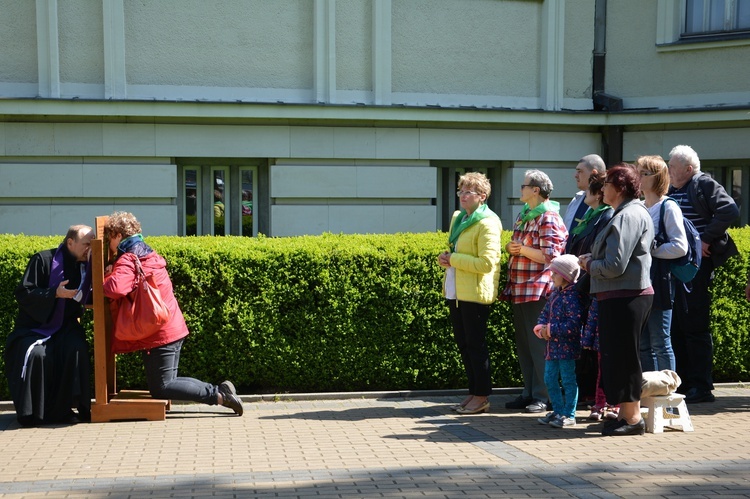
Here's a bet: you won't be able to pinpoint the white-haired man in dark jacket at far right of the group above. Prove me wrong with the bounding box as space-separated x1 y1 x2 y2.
669 145 739 404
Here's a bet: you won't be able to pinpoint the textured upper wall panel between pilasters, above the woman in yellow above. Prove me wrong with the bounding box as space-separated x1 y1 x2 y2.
392 0 541 108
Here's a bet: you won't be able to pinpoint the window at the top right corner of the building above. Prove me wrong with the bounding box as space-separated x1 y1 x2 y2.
682 0 750 38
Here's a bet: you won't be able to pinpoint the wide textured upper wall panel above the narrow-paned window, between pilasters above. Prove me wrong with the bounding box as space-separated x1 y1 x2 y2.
124 0 314 95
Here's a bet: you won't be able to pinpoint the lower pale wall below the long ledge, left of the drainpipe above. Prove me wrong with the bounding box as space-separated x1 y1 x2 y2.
0 117 599 236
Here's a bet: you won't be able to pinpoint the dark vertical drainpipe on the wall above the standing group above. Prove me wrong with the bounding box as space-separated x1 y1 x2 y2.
592 0 623 165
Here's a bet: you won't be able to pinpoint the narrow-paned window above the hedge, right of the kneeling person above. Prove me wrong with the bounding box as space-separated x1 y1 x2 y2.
178 165 258 237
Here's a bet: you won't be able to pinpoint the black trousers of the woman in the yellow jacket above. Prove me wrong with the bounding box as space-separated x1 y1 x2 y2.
446 300 492 397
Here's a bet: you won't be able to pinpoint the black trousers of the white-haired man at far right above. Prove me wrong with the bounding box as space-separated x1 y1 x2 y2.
671 258 714 393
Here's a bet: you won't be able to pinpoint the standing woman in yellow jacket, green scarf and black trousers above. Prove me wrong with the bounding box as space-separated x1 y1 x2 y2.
438 172 502 414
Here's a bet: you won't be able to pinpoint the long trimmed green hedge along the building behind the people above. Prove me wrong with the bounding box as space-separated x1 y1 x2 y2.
0 229 750 399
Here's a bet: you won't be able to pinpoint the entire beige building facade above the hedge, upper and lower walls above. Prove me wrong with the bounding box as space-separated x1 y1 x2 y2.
0 0 750 235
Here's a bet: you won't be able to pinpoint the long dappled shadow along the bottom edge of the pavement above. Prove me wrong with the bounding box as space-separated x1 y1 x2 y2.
4 463 747 498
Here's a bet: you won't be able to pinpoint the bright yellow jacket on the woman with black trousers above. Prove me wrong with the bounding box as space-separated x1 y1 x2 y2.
443 211 503 305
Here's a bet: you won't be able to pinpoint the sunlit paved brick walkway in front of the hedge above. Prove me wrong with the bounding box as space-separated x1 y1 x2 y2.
0 386 750 498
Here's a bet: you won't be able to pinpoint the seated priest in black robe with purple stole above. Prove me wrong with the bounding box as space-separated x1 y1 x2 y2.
5 225 94 426
